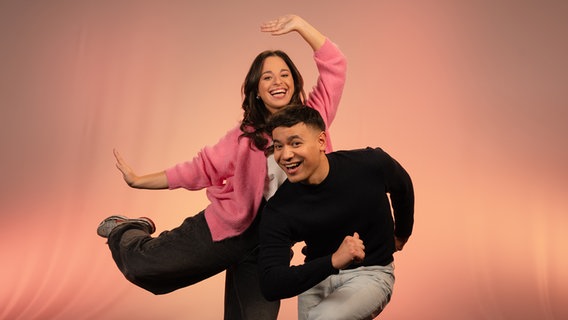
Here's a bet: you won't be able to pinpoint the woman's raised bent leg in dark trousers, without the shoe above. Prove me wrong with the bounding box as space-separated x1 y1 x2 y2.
108 212 253 294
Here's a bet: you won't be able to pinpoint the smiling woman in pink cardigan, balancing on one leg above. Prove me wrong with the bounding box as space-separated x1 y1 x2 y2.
97 15 346 319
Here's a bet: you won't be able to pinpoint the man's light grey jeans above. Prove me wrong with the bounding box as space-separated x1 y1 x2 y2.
298 263 394 320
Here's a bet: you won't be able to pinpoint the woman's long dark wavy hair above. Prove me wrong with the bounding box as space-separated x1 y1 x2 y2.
240 50 306 151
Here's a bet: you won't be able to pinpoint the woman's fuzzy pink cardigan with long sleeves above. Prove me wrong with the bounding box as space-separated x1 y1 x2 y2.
166 39 347 241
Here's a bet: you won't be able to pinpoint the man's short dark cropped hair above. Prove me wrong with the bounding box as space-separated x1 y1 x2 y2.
266 104 325 134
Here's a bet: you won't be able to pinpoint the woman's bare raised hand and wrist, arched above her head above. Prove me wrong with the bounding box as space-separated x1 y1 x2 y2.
260 14 325 51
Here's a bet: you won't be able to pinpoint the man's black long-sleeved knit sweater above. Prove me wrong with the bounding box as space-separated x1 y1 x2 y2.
259 148 414 300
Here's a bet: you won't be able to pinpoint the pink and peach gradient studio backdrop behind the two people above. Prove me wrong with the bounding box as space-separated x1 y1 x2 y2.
0 0 568 319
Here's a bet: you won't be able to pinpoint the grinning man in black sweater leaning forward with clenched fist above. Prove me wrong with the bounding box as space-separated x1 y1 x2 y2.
259 106 414 319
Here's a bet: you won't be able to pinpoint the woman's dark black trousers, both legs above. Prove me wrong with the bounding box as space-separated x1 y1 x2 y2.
108 211 280 320
